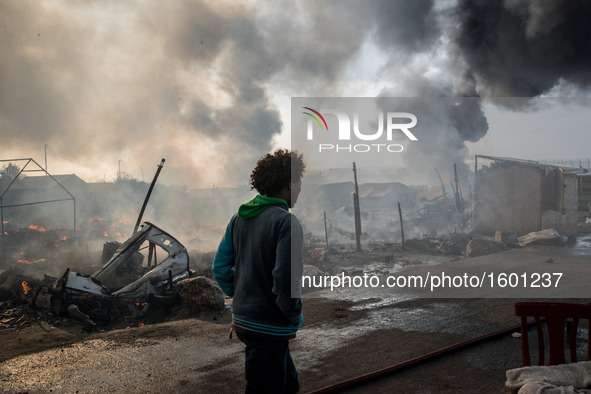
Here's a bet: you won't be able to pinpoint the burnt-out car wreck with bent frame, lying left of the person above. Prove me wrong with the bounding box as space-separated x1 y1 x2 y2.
32 222 191 324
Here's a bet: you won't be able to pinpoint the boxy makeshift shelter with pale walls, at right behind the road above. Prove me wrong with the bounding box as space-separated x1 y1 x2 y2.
473 155 587 235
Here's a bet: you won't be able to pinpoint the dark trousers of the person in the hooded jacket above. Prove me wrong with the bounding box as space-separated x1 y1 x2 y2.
236 332 300 394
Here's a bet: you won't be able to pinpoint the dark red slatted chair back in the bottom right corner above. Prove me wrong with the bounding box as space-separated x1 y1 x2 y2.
515 302 591 366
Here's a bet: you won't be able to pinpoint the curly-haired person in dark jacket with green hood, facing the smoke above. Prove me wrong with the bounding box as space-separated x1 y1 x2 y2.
213 149 305 393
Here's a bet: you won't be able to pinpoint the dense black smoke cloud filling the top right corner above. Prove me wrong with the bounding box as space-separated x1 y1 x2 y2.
457 0 591 97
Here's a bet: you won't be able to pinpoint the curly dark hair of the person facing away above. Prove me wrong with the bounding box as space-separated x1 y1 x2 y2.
250 149 306 197
